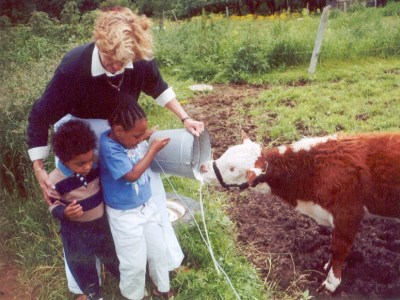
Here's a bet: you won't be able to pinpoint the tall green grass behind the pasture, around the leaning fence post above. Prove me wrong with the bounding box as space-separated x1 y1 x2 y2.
157 3 400 82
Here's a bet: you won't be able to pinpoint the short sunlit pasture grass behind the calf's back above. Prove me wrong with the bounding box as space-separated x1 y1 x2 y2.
245 59 400 143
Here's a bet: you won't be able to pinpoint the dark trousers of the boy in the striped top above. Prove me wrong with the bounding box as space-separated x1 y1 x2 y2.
61 214 119 299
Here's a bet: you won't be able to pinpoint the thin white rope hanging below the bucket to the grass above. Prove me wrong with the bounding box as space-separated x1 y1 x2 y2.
154 160 241 300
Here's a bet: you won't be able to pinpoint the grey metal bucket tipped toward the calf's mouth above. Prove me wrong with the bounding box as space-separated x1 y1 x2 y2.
149 128 211 180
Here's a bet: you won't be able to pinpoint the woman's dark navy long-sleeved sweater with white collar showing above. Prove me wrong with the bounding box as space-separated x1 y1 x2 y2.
28 43 168 148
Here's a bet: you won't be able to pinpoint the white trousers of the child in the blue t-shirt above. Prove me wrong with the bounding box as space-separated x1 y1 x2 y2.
106 200 170 300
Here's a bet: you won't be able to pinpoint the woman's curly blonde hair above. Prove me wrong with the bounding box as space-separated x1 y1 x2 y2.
93 7 153 64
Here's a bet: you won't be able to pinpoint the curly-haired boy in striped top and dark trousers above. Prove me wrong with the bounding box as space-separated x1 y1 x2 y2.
49 120 119 300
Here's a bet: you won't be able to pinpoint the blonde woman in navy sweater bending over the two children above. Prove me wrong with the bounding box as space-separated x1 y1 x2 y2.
28 8 204 296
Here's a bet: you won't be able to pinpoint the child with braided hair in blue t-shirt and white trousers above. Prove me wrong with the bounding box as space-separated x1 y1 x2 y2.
99 94 170 300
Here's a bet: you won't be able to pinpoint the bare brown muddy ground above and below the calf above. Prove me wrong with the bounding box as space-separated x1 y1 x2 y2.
185 85 400 299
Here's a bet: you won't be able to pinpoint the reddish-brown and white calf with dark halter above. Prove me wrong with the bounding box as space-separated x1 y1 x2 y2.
201 133 400 292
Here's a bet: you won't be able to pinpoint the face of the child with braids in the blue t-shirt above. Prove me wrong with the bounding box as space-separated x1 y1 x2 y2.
113 119 147 149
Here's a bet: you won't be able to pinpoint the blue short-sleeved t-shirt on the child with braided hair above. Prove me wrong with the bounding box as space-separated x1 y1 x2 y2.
99 130 151 210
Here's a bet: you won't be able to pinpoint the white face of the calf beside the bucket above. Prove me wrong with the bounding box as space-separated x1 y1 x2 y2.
200 138 261 185
